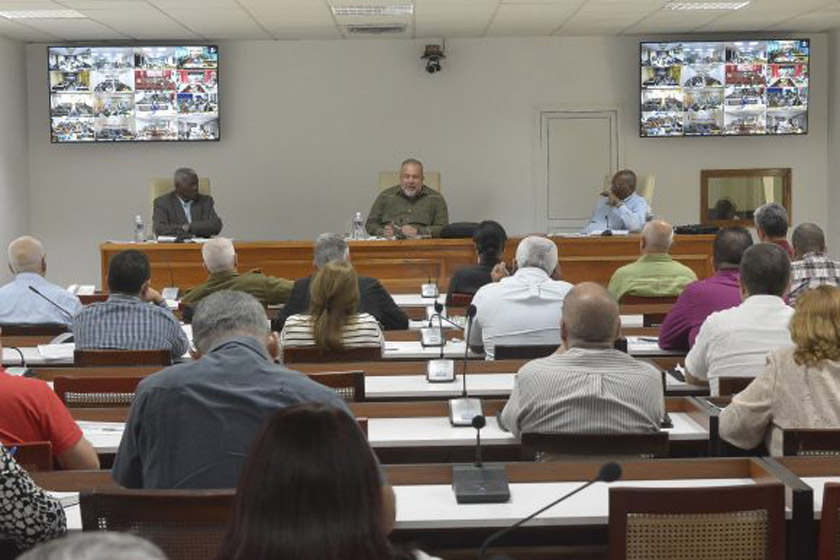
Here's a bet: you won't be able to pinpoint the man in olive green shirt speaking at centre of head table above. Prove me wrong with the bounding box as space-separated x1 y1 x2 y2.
365 159 449 239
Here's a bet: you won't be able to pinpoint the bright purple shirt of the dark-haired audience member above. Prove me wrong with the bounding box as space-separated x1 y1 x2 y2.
659 268 741 350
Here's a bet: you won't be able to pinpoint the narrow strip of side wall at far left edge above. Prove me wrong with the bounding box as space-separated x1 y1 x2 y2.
0 37 29 282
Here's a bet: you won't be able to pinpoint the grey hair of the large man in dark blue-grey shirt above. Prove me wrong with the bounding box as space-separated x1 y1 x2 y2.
192 290 269 354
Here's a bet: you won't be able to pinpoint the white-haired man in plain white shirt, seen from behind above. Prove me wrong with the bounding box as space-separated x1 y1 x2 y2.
470 236 572 360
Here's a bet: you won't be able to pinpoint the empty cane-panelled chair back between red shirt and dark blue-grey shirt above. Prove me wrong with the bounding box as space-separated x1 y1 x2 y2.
53 376 143 408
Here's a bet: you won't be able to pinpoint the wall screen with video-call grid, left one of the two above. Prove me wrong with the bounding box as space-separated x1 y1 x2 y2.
49 46 219 143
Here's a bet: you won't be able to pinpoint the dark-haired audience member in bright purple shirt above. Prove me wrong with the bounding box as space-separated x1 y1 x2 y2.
659 227 752 350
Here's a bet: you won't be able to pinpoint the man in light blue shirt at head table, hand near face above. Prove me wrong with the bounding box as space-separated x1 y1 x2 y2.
582 169 650 233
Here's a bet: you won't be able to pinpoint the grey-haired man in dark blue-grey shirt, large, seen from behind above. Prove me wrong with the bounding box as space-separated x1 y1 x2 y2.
112 290 349 489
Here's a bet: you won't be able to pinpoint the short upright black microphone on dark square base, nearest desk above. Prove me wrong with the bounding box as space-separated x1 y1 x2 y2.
452 414 510 504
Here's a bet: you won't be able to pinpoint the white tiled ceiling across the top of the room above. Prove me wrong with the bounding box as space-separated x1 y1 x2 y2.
0 0 840 42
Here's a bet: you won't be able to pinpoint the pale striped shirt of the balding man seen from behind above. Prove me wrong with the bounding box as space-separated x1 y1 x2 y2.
501 348 665 437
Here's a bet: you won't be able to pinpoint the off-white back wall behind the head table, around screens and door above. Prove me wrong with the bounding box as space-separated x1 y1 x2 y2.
27 35 828 283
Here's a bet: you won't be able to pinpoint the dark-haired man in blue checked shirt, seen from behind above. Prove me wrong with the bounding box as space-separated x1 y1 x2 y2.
73 250 190 358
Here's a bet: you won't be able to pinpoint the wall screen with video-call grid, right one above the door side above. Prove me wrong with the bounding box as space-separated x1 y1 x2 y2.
641 39 810 137
